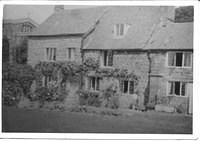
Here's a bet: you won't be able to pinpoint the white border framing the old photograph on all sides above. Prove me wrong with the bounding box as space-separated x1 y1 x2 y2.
0 0 200 140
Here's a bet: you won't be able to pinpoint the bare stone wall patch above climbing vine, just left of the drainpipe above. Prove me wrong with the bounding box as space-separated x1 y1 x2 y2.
113 51 149 94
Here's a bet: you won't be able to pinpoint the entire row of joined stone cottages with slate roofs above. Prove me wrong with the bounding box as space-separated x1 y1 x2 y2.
28 6 193 113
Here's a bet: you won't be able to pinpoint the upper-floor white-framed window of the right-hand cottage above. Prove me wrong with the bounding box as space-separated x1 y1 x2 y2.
168 52 192 67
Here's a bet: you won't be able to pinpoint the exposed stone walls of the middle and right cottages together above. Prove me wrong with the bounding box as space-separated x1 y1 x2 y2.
84 50 193 111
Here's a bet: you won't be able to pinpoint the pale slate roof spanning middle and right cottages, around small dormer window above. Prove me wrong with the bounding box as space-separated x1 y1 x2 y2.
84 6 193 50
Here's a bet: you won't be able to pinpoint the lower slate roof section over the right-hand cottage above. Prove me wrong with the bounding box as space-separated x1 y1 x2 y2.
146 22 193 50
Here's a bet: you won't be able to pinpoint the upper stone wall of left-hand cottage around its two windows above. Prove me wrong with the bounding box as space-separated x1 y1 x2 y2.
28 37 81 66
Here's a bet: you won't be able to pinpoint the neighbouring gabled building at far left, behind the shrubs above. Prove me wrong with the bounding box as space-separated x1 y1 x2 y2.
2 18 38 63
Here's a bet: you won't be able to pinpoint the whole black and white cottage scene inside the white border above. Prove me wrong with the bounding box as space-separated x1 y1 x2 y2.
2 1 197 139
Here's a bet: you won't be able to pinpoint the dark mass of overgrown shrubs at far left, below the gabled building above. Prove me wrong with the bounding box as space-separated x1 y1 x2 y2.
2 64 35 105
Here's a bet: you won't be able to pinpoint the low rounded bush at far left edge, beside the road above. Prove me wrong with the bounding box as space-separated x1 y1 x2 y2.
2 81 23 106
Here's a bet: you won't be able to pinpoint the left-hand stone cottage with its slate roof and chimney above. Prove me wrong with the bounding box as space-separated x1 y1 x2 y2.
28 5 102 91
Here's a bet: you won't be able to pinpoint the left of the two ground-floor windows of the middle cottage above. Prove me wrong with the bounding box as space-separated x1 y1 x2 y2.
88 77 100 91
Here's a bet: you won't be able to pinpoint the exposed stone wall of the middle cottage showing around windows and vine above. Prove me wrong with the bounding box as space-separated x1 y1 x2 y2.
84 51 149 107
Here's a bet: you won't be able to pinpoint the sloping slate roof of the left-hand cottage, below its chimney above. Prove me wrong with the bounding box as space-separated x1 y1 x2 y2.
30 7 103 36
